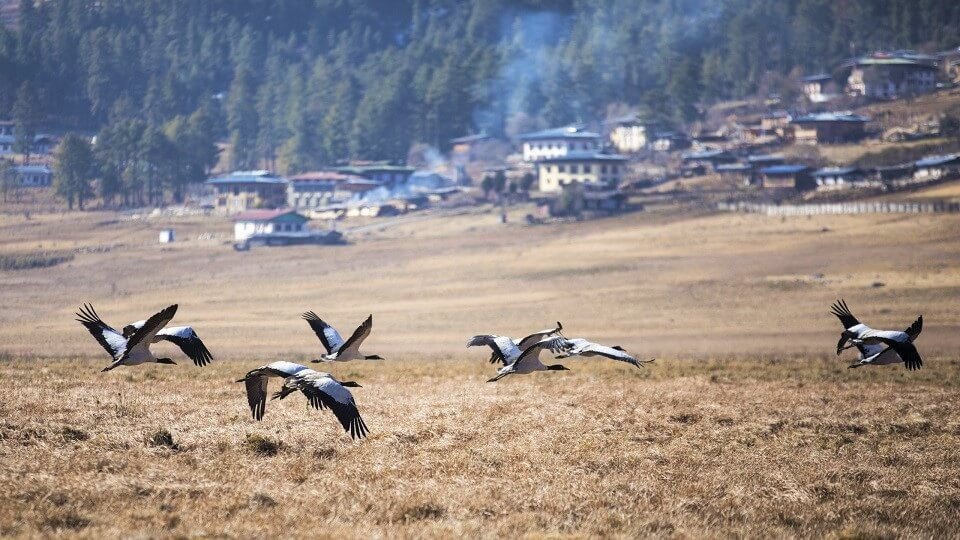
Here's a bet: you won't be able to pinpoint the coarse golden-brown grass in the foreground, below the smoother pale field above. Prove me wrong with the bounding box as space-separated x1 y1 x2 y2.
0 351 960 537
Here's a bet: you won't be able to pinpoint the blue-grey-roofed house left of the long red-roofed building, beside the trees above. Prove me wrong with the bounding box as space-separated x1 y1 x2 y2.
206 171 287 214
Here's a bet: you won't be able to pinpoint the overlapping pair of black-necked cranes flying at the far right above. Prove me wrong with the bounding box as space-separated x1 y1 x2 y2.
830 299 923 370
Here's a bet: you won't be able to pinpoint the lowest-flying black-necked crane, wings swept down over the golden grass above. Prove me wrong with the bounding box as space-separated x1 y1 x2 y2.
237 361 369 439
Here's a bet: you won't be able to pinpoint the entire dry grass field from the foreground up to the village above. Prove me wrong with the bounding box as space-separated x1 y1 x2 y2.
0 208 960 537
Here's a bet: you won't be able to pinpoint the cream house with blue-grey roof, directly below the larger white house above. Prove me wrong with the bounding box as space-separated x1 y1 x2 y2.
537 152 627 192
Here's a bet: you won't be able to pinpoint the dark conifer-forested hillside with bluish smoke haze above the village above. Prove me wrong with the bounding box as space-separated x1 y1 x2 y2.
0 0 960 170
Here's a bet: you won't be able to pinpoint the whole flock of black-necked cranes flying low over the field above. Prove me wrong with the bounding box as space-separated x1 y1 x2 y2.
76 299 923 439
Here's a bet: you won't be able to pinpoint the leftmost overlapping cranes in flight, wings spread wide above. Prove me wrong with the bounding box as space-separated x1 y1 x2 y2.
76 304 213 371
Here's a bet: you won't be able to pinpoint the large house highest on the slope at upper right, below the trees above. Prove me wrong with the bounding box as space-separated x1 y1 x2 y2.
844 51 939 99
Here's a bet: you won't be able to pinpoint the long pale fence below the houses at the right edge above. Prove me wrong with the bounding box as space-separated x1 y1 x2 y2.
717 202 960 216
